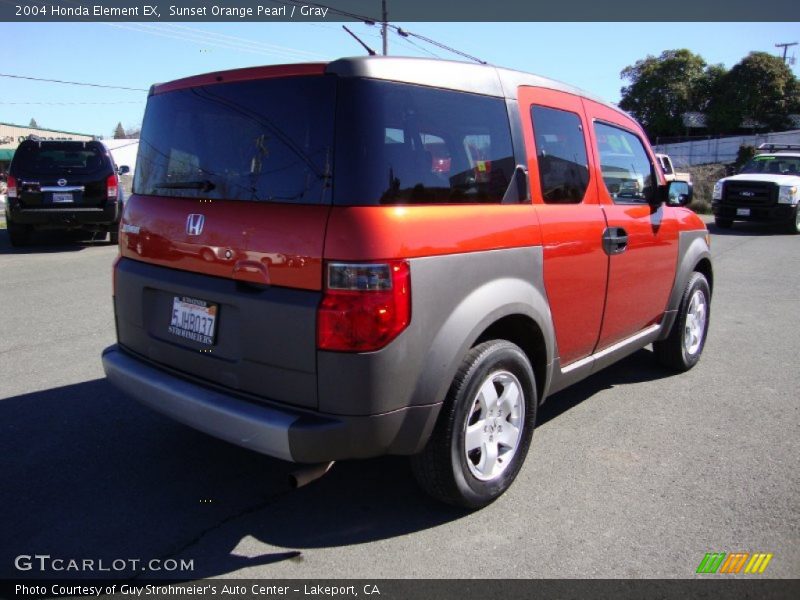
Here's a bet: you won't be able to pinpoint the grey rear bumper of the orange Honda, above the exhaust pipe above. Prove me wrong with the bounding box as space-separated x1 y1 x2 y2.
103 345 440 463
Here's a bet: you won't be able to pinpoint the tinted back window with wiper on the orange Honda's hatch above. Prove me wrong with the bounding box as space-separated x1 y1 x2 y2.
133 76 336 204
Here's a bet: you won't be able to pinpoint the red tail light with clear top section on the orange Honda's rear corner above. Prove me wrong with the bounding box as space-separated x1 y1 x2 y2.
317 260 411 352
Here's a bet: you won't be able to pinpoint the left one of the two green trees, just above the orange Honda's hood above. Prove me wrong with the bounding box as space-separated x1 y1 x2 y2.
619 48 721 140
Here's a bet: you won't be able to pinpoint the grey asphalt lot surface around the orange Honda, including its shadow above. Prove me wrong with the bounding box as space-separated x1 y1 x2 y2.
0 218 800 579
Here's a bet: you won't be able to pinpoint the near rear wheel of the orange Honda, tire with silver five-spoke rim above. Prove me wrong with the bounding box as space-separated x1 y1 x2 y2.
411 340 538 509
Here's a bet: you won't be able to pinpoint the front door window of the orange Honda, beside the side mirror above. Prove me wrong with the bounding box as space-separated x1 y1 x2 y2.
594 123 655 204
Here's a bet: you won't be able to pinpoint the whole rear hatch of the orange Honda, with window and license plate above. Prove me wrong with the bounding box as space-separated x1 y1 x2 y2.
115 69 335 408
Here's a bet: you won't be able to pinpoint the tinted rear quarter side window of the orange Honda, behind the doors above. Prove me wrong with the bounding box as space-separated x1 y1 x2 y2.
334 79 515 205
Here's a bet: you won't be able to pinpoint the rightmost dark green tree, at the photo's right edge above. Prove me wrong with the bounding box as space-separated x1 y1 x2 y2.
707 52 800 133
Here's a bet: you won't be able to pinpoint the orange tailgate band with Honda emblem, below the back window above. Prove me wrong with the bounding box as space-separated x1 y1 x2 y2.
119 195 330 290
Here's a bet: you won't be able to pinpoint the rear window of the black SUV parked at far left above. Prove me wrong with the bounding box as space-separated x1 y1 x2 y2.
12 142 109 176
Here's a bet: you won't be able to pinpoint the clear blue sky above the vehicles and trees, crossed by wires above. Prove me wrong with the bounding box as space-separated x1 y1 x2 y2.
0 23 800 136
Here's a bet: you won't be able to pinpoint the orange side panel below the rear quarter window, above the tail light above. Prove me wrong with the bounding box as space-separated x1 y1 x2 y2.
325 204 541 261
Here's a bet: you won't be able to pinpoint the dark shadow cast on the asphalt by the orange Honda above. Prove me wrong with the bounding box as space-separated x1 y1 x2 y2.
0 351 668 579
